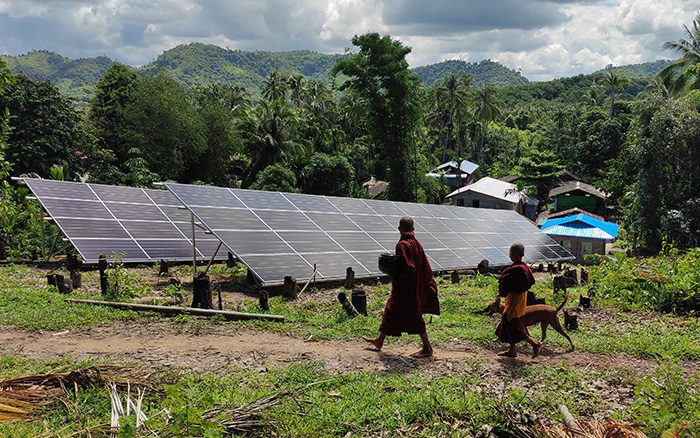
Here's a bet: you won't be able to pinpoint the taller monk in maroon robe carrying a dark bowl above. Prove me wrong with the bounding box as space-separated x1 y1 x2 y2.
363 216 440 357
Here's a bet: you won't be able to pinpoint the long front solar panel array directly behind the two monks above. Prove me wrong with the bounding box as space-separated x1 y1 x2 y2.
165 183 574 285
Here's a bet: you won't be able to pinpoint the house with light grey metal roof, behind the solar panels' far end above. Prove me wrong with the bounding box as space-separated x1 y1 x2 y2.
447 177 538 220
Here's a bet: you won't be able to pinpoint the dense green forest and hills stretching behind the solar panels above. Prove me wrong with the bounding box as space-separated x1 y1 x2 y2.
0 17 700 255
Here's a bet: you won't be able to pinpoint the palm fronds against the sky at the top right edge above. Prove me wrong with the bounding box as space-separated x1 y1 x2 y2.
657 12 700 96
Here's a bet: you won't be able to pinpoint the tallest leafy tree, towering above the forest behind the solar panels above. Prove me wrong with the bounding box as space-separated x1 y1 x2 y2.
333 33 421 201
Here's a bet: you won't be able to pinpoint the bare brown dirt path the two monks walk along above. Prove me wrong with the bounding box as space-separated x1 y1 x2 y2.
0 321 668 373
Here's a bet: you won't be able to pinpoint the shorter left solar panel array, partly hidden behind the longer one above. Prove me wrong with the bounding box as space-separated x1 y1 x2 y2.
22 178 225 263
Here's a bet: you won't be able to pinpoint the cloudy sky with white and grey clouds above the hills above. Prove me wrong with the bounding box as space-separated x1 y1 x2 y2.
0 0 700 81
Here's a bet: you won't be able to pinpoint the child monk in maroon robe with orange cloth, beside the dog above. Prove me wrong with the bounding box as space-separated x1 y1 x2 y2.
496 243 542 359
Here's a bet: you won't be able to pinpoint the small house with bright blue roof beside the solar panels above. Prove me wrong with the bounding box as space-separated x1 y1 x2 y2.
541 213 620 263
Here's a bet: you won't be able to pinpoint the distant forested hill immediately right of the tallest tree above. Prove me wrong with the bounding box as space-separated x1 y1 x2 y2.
412 59 530 88
